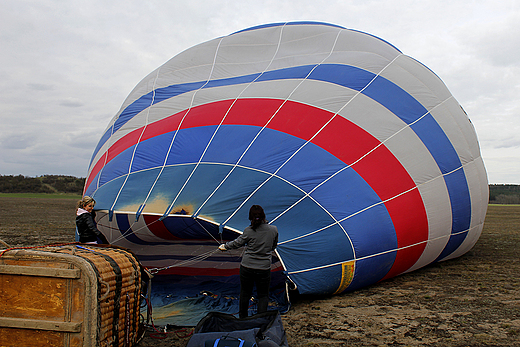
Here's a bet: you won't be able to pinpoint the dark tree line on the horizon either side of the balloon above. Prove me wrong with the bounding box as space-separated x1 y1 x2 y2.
0 175 520 204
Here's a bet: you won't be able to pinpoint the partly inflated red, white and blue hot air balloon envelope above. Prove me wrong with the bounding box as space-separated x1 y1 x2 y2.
85 22 488 304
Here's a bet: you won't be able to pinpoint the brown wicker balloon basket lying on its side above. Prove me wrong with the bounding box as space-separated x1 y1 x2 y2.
0 244 143 347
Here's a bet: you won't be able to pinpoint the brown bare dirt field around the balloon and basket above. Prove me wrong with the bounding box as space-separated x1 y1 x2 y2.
0 197 520 347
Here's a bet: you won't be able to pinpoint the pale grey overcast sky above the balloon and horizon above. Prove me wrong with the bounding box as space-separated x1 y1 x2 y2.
0 0 520 184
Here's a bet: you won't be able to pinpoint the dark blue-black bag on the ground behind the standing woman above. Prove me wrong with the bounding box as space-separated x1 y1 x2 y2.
186 311 289 347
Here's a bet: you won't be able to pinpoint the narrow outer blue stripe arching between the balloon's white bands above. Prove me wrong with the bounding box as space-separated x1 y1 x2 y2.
94 64 471 247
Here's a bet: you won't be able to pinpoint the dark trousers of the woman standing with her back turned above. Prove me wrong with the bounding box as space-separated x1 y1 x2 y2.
238 265 271 318
